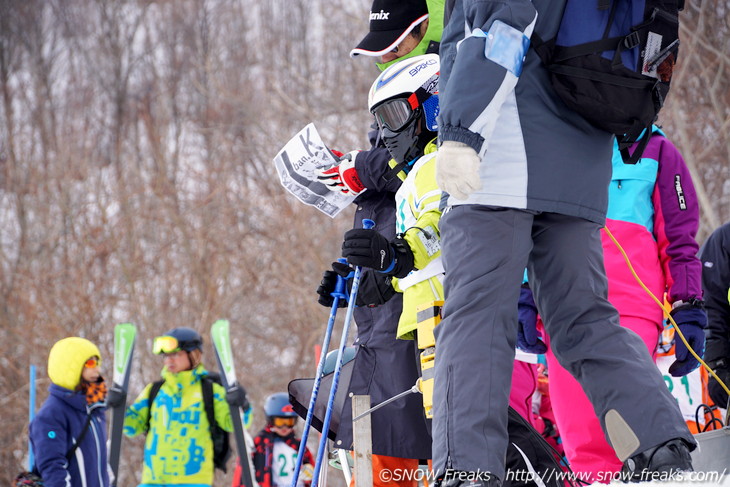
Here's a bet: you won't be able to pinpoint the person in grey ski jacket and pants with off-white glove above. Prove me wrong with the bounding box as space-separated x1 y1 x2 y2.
433 0 695 486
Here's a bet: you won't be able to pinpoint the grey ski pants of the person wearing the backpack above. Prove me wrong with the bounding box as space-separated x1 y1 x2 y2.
433 205 694 479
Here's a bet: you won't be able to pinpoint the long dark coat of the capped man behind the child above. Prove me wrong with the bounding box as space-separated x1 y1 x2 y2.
335 133 431 459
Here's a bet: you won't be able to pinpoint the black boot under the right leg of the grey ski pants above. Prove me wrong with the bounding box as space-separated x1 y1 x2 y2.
621 438 693 482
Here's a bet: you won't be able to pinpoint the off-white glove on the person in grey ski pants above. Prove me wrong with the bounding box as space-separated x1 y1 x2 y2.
436 140 482 200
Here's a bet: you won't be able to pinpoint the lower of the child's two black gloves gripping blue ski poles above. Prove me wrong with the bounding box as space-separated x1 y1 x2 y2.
317 262 395 308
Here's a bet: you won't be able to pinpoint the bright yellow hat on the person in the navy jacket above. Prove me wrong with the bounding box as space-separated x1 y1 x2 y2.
48 337 101 391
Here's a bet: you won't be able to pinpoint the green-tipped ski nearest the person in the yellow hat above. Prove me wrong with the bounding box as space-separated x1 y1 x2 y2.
109 323 137 487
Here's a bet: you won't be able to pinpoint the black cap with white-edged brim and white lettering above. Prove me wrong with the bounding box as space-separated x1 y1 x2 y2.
350 0 428 56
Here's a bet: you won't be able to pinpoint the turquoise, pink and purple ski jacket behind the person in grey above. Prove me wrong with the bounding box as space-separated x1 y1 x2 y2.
602 126 702 326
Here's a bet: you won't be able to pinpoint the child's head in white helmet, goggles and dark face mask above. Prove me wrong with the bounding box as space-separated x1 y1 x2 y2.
368 54 441 163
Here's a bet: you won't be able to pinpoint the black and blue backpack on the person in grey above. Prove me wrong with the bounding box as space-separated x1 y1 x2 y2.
531 0 684 164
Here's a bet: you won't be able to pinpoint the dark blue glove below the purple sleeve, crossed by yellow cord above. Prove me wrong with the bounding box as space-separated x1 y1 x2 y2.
669 300 707 377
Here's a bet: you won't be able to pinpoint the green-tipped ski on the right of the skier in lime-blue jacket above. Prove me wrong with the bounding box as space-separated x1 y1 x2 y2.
210 320 256 487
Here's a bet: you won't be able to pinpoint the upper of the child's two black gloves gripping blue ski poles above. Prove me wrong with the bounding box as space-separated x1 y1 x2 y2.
342 228 413 277
